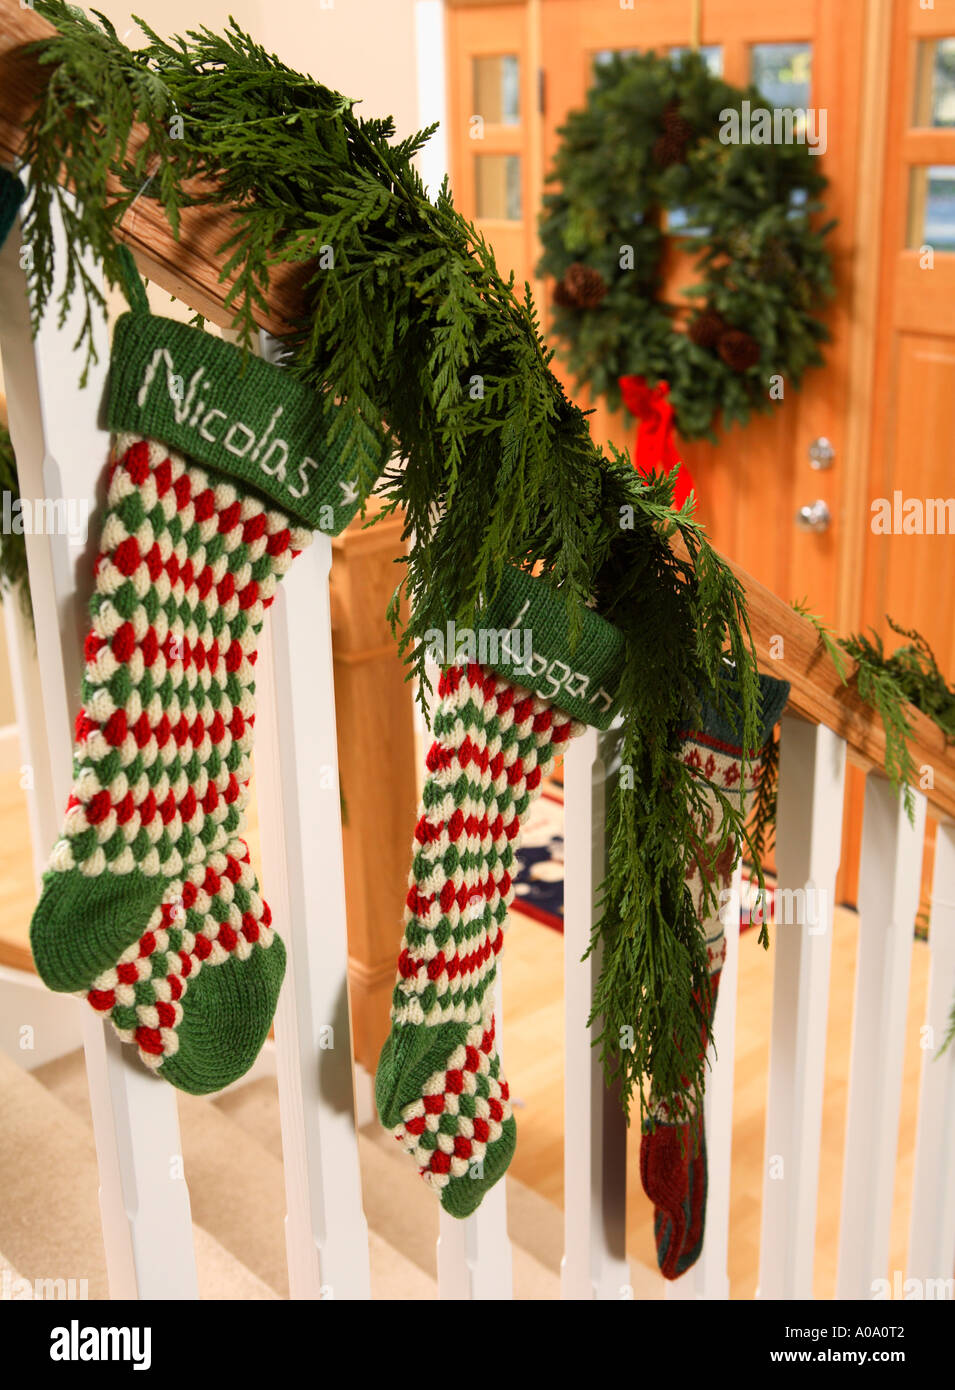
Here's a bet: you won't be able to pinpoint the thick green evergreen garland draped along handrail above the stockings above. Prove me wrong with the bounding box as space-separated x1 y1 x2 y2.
14 0 778 1115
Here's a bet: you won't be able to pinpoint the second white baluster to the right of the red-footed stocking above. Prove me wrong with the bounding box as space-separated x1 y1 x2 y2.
835 773 926 1298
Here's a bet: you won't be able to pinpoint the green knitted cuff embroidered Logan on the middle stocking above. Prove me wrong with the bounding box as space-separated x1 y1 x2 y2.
477 569 624 728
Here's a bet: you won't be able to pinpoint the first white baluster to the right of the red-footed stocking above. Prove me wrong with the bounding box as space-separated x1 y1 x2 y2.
758 716 845 1298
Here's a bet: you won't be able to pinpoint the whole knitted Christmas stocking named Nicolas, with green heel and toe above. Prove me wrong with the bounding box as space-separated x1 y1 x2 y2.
31 296 372 1094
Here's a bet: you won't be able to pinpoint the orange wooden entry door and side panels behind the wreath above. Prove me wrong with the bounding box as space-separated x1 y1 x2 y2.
448 0 955 901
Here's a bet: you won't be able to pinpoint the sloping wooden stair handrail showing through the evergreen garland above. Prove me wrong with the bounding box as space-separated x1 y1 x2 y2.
0 0 955 820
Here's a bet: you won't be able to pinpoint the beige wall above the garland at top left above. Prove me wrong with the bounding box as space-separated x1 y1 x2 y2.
0 0 420 727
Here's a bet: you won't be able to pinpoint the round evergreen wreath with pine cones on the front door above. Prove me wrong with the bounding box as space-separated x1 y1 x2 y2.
538 53 834 439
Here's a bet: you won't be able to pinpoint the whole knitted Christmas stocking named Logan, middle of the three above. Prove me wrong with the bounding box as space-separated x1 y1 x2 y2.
375 570 623 1216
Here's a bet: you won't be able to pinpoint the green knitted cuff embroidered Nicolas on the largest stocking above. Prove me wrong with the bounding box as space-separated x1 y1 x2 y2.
107 313 372 535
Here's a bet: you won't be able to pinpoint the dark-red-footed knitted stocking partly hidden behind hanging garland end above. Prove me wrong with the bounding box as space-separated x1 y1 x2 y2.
639 676 790 1279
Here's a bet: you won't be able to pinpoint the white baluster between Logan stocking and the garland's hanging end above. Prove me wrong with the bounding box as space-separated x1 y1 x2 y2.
560 728 630 1300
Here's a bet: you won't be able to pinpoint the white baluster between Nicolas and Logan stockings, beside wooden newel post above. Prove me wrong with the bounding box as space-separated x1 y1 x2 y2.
256 534 374 1298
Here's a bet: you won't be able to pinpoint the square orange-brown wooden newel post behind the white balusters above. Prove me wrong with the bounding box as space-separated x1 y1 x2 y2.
331 499 417 1072
